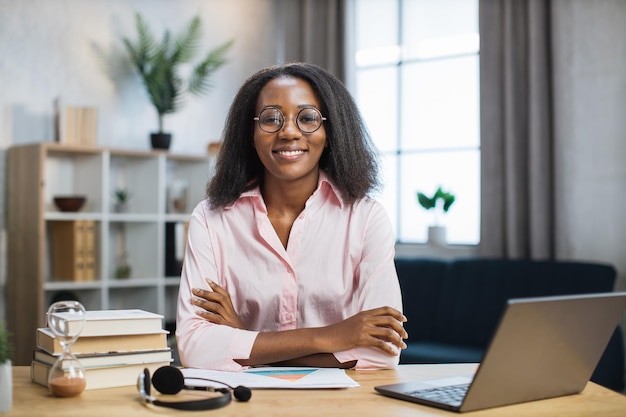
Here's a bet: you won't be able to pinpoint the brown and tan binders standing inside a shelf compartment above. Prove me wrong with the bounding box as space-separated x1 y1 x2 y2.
50 220 96 281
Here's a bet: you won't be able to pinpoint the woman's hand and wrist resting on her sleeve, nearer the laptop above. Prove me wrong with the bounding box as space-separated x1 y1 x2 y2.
320 307 408 355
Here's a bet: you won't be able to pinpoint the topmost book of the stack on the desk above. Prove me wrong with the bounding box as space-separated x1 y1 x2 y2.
46 309 163 337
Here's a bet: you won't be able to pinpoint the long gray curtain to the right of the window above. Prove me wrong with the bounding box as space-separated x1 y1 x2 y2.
479 0 555 259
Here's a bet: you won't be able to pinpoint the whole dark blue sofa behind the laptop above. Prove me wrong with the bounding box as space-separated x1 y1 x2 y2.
395 257 625 391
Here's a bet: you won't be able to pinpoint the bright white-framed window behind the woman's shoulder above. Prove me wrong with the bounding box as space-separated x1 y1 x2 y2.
348 0 480 244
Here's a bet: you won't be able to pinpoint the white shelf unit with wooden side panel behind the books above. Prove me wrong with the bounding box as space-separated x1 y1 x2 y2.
6 143 211 365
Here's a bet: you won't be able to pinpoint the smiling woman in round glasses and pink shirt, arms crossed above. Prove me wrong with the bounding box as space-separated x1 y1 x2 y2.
176 63 407 371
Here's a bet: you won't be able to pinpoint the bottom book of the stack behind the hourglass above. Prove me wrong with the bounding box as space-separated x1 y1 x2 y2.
30 361 170 390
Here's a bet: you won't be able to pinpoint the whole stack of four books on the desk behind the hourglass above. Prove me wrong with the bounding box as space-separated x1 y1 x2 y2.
30 309 172 390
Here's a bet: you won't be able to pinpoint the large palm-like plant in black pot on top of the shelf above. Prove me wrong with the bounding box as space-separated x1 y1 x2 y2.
123 13 233 149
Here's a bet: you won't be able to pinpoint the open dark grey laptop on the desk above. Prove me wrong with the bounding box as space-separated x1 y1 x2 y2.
374 292 626 412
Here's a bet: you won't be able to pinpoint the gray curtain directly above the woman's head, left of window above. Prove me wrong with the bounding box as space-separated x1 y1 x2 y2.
275 0 346 81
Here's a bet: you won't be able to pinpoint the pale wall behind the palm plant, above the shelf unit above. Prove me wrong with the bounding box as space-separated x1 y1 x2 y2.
0 0 278 320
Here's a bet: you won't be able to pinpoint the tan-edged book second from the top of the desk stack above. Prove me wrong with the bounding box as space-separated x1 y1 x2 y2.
36 327 169 355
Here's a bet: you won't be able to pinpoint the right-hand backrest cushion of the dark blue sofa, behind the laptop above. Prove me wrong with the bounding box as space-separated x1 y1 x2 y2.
429 259 616 348
